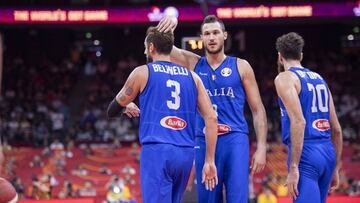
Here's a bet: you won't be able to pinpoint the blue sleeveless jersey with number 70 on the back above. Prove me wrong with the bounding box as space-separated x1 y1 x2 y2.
278 67 331 145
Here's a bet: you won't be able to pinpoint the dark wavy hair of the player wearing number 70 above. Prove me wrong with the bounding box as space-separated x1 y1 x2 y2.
276 32 305 60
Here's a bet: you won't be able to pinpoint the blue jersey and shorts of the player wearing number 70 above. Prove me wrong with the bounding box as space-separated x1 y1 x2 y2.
279 67 336 203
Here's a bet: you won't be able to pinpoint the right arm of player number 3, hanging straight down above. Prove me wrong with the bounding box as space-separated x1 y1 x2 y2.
191 72 218 190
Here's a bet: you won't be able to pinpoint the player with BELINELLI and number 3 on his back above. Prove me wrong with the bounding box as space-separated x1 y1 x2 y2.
108 27 218 203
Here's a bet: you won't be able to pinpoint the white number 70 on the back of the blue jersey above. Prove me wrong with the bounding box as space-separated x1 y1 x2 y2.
307 83 329 113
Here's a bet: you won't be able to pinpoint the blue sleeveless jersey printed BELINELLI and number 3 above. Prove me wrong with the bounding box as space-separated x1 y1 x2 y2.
139 61 197 147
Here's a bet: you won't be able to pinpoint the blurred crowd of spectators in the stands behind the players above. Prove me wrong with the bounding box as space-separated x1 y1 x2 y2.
0 30 360 203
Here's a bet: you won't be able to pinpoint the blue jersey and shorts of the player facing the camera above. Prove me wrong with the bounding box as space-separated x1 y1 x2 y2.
195 56 249 203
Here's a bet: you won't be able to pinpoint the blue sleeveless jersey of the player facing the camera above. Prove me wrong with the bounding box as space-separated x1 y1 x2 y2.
195 56 248 136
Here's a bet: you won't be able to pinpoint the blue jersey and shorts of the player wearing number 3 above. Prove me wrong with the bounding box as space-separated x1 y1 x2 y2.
139 61 197 203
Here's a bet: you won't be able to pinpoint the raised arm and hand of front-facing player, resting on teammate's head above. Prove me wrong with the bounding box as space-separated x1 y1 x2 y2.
156 16 200 70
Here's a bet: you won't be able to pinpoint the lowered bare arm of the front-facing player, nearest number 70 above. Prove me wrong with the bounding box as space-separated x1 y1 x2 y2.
237 59 268 174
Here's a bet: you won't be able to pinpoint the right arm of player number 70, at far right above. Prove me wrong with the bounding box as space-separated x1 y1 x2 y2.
329 90 343 192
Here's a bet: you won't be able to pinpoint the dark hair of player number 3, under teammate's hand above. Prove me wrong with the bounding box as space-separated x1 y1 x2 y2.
146 27 174 55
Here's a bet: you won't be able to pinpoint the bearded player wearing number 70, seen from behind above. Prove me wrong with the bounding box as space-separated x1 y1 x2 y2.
275 32 342 203
